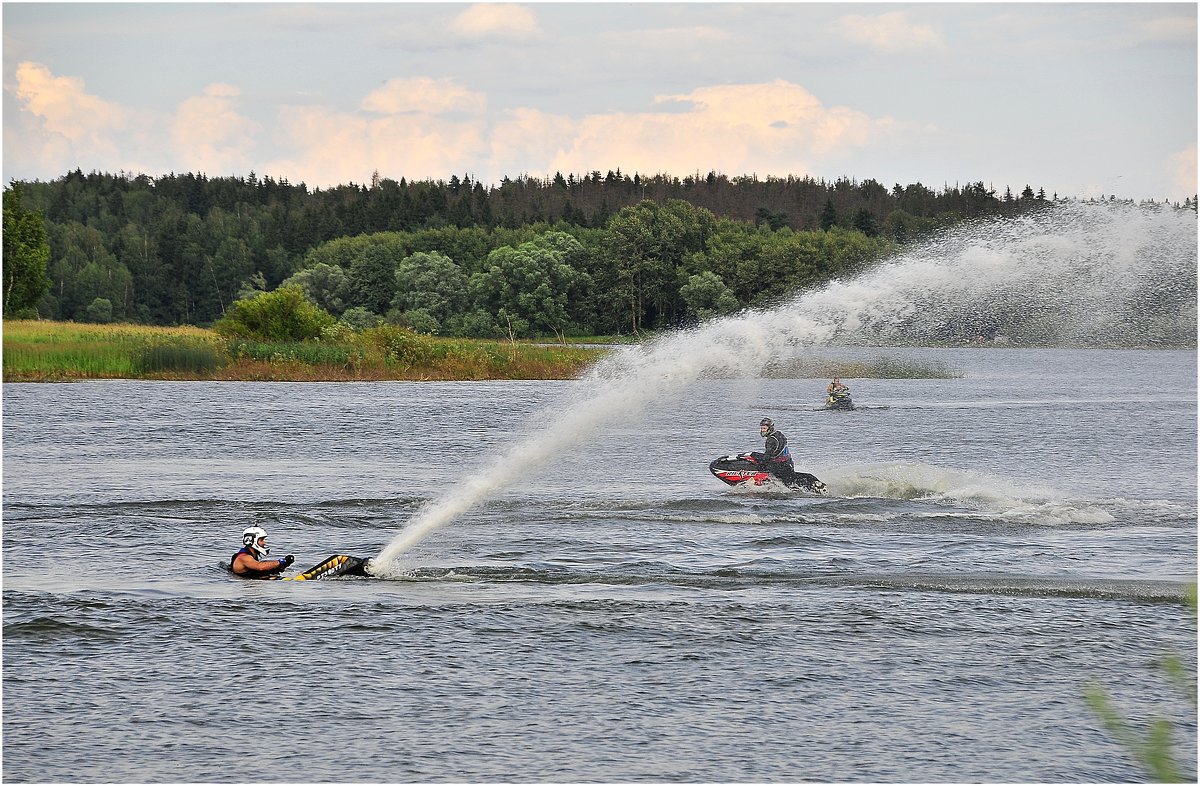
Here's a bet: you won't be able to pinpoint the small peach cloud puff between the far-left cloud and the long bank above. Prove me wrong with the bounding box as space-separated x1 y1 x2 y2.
170 83 262 175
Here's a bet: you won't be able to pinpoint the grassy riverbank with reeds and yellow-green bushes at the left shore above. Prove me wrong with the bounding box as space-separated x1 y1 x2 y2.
4 319 607 382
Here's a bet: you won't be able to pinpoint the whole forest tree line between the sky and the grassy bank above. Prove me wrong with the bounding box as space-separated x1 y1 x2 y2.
4 169 1099 337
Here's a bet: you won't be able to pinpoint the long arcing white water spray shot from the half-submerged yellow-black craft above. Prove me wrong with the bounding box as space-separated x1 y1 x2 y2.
372 203 1196 574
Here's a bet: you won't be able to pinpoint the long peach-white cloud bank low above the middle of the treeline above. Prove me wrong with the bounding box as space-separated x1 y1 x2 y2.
259 79 898 187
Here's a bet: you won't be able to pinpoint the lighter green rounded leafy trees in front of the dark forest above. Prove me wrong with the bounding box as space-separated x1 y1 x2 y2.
265 200 894 337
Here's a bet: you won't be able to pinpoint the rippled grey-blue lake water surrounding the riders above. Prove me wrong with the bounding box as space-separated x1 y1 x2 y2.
2 348 1198 782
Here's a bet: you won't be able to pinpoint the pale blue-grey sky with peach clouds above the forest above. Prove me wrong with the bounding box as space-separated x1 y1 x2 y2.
2 2 1198 202
